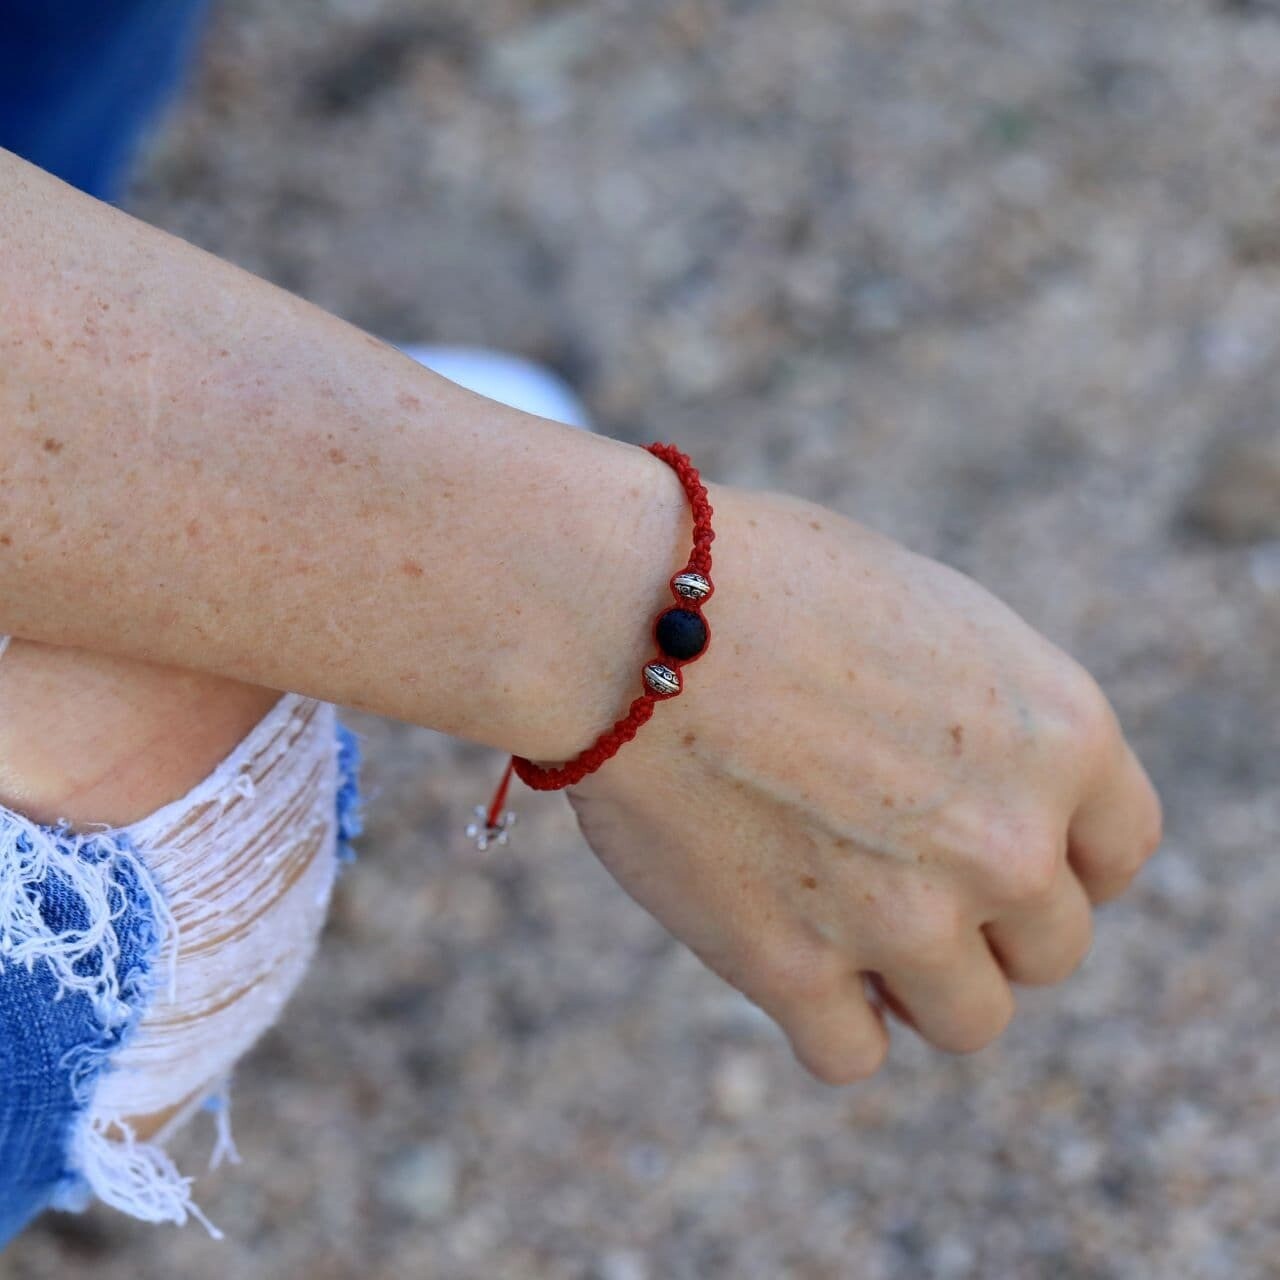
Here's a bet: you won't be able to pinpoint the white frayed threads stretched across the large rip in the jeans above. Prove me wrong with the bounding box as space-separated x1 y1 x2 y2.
77 694 338 1234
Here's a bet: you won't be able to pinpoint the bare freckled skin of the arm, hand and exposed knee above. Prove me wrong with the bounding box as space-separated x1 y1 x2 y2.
0 152 1161 1084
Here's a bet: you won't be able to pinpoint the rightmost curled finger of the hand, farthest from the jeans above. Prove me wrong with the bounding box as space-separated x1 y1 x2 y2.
1068 740 1164 902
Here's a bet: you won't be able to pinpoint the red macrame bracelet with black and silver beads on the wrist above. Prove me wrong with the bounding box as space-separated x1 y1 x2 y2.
467 444 716 850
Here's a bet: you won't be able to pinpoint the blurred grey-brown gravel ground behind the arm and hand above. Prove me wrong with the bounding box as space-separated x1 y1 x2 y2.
0 0 1280 1280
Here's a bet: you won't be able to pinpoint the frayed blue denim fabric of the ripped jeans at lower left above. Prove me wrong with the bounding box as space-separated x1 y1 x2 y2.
0 719 362 1248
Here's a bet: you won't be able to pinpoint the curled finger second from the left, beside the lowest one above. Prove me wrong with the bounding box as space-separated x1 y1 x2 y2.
877 929 1014 1053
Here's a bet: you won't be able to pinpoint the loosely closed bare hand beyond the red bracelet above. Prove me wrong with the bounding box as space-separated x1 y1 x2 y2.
567 485 1161 1084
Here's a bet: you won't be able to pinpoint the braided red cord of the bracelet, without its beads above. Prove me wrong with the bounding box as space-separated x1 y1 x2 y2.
486 443 716 829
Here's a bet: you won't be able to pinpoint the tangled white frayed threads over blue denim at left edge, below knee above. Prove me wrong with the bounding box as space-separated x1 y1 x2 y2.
0 805 178 1032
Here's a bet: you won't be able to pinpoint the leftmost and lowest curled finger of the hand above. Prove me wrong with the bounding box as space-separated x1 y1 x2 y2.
741 957 888 1084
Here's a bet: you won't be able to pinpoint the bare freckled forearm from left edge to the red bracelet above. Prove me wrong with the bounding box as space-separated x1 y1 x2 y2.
0 152 689 760
